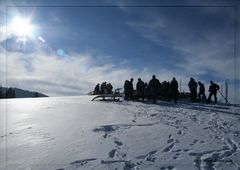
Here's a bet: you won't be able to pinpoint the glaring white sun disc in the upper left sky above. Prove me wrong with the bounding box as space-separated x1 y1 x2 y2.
10 17 34 39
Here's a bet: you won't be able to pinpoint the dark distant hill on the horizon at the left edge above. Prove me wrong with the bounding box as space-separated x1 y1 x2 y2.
1 87 48 98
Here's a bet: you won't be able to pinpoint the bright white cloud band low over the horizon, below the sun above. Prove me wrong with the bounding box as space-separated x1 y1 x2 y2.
0 44 190 96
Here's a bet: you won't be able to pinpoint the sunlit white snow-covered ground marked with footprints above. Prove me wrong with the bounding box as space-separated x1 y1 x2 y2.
0 96 240 170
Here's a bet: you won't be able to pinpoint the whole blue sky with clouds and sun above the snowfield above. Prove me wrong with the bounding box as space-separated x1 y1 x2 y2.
0 0 240 103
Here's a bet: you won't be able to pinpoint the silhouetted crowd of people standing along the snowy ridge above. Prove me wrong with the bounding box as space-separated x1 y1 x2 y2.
93 75 220 103
